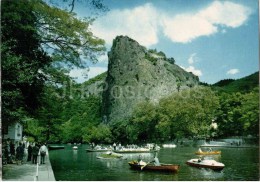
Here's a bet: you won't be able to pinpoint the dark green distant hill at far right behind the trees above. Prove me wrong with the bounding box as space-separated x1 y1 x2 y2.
212 72 259 93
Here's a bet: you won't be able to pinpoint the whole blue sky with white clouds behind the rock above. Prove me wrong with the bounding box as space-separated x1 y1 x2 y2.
70 0 259 84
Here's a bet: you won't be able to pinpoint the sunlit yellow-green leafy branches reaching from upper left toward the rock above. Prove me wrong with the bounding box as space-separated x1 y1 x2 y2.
32 1 105 67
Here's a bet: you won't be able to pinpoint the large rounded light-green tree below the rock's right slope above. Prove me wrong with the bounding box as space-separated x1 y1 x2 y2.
157 87 218 139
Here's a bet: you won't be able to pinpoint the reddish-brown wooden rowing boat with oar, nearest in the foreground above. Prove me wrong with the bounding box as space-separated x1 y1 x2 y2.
128 161 180 172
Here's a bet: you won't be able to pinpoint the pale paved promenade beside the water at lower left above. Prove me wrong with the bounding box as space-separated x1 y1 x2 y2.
2 156 55 181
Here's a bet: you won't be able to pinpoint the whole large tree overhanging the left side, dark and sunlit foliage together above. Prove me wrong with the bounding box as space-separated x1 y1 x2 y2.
1 0 105 141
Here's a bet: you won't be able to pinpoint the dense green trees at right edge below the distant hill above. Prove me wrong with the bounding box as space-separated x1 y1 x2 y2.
217 88 259 136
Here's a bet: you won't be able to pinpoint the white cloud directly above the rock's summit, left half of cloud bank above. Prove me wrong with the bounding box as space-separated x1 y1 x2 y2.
92 3 158 46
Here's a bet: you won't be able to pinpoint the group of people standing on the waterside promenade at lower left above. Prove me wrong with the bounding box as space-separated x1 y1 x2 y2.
2 140 48 164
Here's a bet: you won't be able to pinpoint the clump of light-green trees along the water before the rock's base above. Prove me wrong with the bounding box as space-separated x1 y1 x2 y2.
123 87 218 142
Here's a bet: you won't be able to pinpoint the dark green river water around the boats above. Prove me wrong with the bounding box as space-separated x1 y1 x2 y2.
49 145 259 181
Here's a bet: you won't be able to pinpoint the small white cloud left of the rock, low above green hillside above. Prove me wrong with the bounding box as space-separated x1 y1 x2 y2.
69 66 107 83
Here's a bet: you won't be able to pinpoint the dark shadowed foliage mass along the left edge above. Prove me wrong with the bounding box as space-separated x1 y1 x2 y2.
1 1 51 128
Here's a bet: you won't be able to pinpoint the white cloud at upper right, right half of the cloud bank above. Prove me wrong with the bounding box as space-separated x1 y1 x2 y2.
163 1 251 43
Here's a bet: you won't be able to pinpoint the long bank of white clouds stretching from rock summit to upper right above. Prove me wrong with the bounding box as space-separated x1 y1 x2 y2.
92 1 251 47
